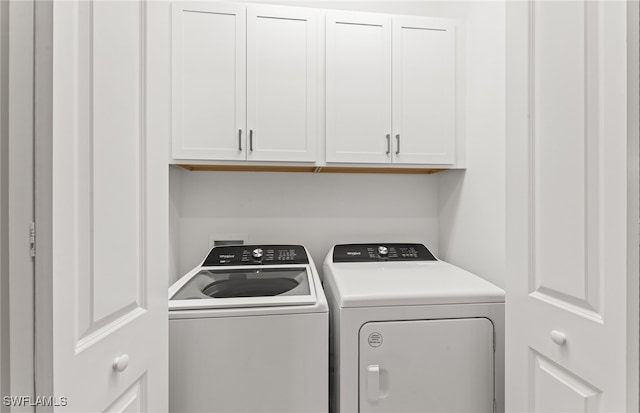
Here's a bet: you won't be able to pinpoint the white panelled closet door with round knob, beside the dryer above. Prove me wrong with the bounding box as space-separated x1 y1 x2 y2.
505 0 638 413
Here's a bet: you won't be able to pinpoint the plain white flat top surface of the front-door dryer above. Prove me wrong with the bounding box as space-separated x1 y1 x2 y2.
326 261 504 307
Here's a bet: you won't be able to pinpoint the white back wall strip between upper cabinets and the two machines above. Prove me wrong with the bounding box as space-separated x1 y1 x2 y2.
170 167 438 282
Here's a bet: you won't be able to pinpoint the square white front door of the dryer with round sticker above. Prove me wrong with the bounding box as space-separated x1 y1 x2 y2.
359 318 494 413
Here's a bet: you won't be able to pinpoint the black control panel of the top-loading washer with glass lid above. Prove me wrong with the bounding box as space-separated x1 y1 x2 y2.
203 245 309 267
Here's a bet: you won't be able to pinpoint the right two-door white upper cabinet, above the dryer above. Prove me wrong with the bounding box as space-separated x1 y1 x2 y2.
326 12 456 164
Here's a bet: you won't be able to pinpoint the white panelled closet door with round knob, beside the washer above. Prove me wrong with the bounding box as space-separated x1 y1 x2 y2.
49 1 169 412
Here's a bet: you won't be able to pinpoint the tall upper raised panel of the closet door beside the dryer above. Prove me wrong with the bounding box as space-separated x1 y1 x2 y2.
531 2 601 317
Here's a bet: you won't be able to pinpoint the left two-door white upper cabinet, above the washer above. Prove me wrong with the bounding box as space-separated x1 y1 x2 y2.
172 3 318 162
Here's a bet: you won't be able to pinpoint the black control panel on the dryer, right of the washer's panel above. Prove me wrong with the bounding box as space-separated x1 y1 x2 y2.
333 244 436 262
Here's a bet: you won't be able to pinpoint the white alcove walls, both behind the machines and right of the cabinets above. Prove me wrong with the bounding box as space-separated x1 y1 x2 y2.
170 0 505 286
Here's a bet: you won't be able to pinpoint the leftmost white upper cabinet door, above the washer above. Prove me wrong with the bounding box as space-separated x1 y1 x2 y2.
172 2 246 160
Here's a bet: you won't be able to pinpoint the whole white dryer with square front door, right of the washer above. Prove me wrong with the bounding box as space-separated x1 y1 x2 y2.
323 243 504 413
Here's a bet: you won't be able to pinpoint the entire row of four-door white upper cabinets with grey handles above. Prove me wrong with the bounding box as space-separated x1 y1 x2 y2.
171 2 460 169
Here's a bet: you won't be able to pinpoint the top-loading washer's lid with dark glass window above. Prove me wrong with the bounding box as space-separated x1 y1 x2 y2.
169 265 316 310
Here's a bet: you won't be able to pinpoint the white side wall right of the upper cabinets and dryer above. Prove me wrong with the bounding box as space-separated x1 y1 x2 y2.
438 1 506 288
